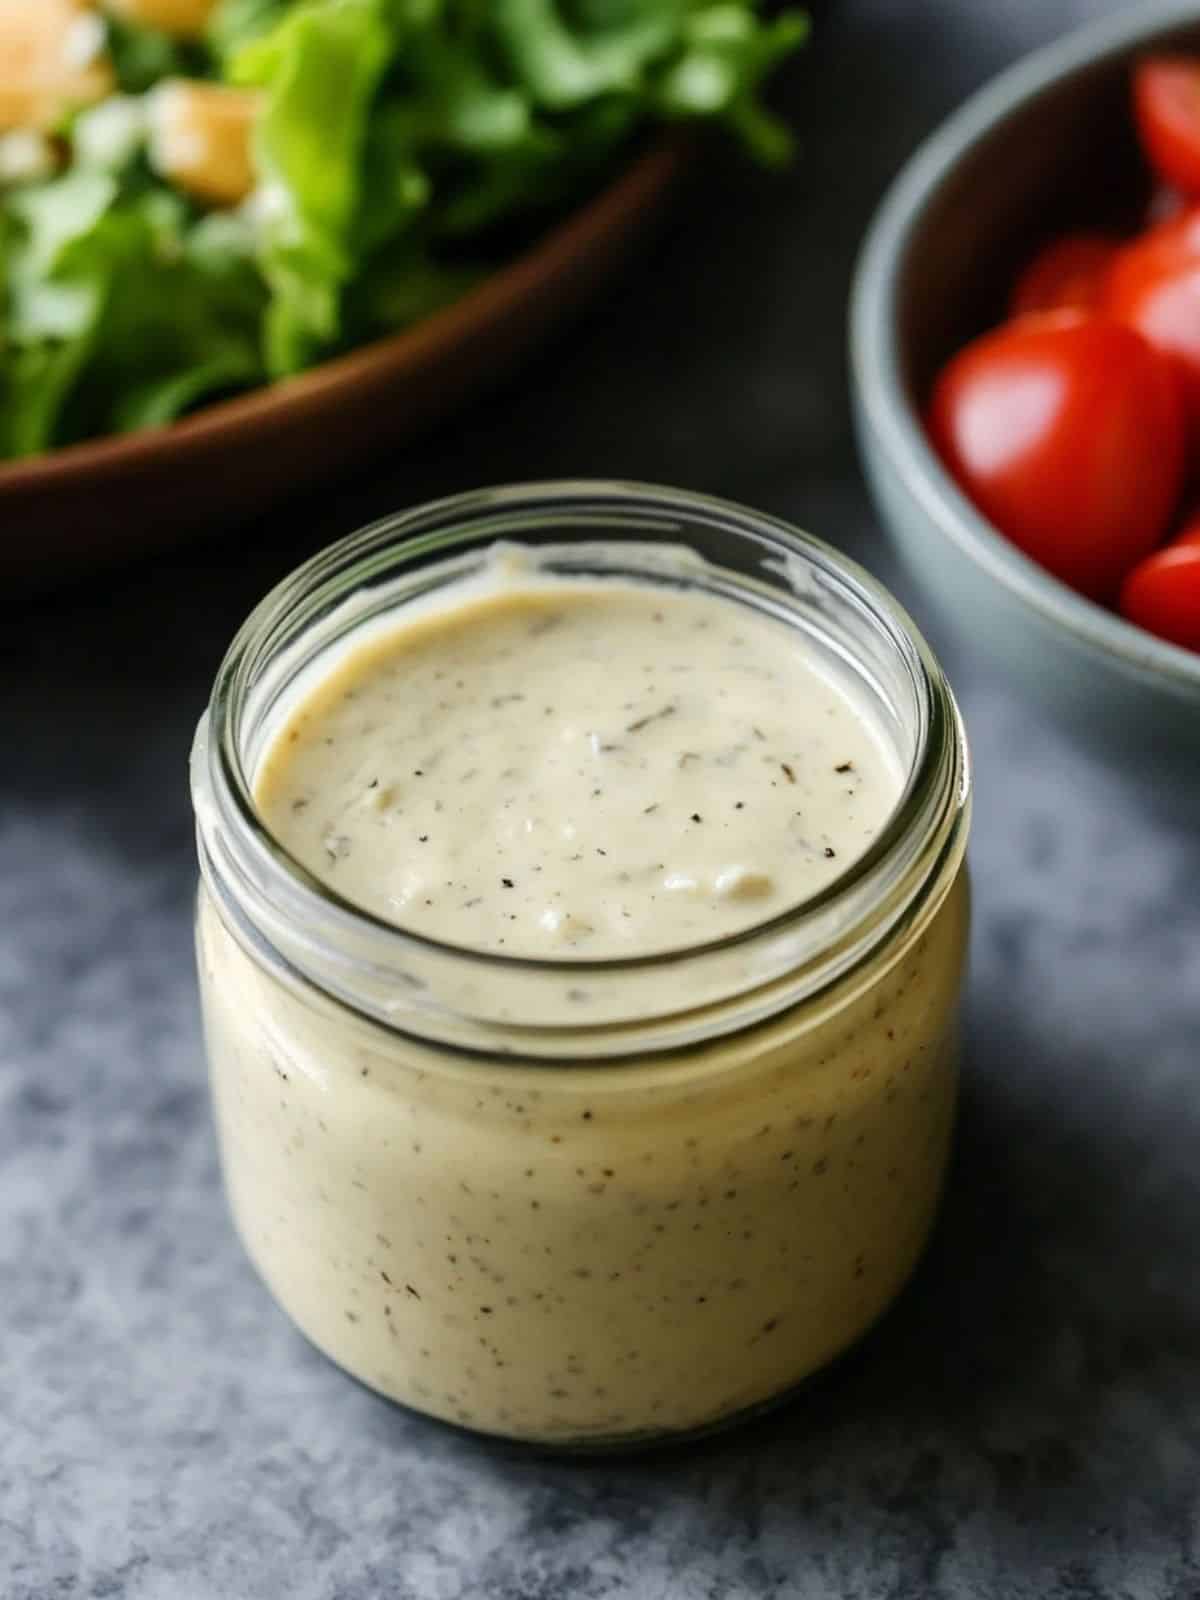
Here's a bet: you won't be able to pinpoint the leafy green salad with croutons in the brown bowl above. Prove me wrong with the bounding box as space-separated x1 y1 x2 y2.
0 0 806 458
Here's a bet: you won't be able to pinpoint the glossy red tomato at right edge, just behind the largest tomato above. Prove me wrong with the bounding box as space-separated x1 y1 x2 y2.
1101 208 1200 437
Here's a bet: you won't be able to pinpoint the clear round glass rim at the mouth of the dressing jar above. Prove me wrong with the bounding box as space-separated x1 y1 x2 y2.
192 480 970 1043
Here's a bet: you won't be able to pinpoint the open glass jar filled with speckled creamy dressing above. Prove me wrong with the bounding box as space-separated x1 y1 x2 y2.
192 483 968 1448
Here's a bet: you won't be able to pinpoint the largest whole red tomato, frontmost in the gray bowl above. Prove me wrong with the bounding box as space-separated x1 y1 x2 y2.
930 312 1186 600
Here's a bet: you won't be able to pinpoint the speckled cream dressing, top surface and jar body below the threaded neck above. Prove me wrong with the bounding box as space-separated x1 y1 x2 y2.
198 556 966 1445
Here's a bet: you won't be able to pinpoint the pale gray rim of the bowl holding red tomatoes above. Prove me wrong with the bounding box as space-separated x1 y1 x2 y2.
850 0 1200 693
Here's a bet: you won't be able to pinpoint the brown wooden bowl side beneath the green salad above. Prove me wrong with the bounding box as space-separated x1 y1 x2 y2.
0 138 685 578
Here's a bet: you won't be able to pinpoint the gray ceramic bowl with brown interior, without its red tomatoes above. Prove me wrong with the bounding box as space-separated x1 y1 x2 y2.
851 0 1200 770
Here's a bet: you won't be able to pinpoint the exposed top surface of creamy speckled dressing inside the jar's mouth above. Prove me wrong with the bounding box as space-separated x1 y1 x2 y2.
256 581 901 958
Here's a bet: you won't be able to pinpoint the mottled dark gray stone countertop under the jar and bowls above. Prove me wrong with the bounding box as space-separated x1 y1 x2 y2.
0 0 1200 1600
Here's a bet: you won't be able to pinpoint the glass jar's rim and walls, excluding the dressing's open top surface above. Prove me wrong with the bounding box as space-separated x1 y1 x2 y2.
192 483 970 1448
